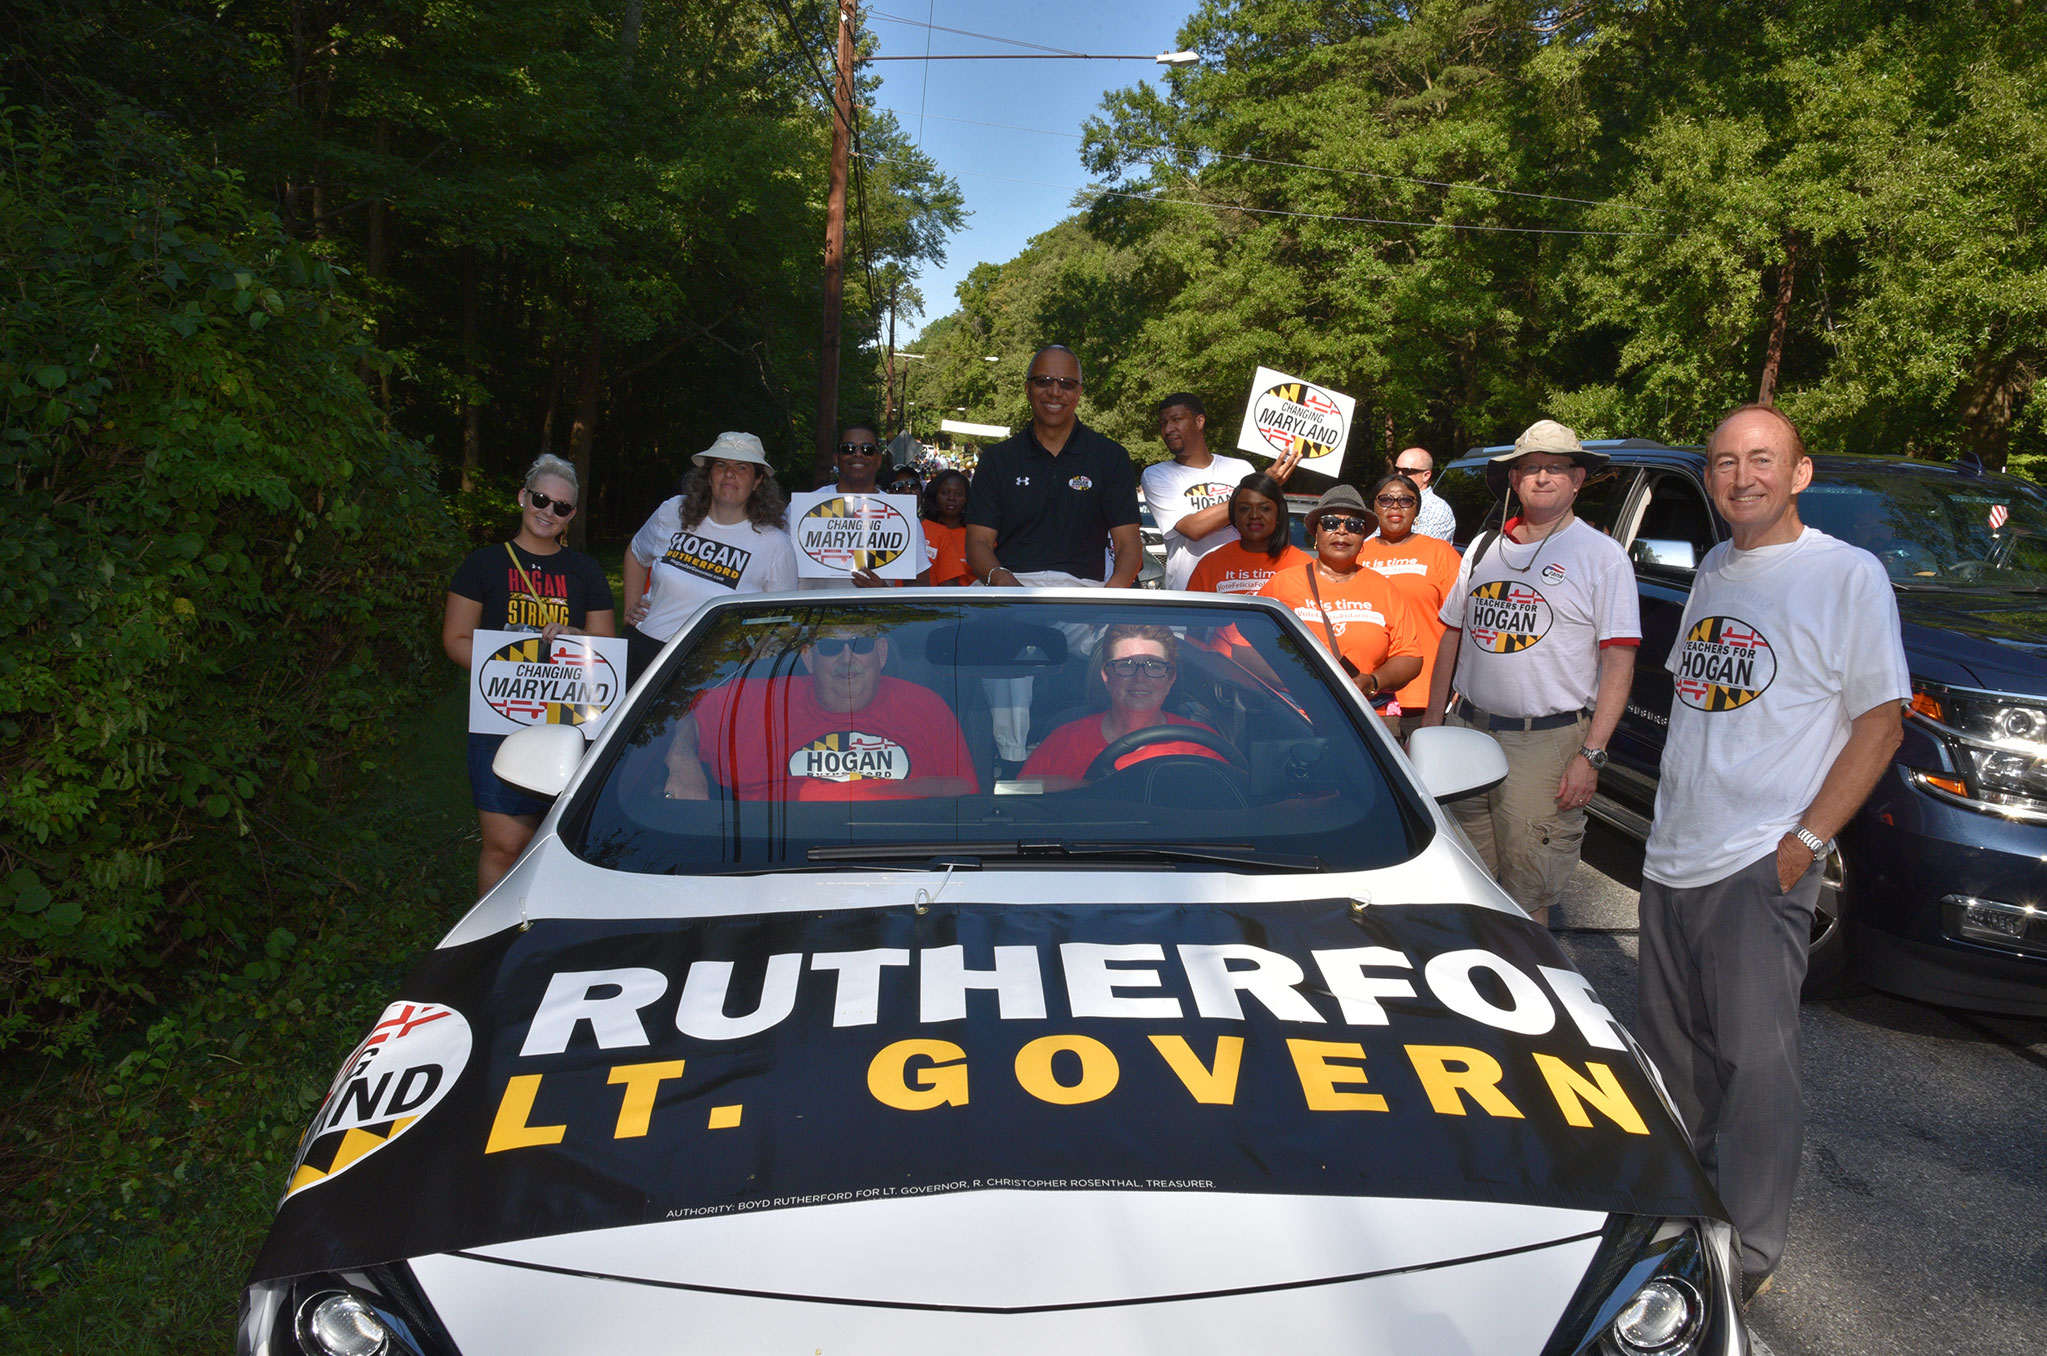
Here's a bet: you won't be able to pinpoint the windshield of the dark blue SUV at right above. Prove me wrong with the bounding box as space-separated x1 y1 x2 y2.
1797 463 2047 588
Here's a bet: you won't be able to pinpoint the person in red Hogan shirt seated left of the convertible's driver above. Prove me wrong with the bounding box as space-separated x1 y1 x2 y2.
663 625 981 801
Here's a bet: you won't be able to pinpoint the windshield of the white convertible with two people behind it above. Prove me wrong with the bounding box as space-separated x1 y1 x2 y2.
563 590 1431 873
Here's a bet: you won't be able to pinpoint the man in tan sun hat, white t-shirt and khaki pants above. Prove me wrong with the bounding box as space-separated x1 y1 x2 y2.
1423 420 1642 924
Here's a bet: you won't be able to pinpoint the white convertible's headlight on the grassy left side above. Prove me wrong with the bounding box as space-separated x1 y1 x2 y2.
235 1262 454 1356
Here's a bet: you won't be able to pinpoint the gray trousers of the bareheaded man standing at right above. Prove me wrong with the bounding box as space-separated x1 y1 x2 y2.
1636 850 1820 1276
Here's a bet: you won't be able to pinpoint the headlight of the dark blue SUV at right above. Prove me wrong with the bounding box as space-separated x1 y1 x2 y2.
1912 682 2047 823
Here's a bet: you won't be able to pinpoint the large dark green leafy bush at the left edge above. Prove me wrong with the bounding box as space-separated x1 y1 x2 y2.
0 109 454 1053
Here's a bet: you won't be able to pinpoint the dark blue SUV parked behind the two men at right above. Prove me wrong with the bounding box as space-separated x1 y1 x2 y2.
1435 438 2047 1016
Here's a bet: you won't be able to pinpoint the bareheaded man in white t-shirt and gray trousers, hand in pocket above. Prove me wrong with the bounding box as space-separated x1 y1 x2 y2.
1638 406 1912 1299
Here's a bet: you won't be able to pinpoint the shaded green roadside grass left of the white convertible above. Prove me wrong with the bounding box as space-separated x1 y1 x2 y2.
0 672 477 1356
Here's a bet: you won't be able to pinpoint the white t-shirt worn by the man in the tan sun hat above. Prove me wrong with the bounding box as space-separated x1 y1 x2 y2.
1437 518 1642 715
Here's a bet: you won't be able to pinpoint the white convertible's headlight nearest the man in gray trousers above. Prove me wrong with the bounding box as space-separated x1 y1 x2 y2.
1543 1215 1744 1356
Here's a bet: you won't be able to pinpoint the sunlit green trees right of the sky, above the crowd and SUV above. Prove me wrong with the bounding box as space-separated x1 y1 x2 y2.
921 0 2047 477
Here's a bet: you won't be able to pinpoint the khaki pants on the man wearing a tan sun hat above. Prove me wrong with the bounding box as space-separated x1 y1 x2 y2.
1443 711 1593 914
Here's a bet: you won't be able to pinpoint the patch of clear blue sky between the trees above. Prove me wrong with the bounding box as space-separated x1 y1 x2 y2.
860 0 1197 342
